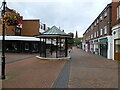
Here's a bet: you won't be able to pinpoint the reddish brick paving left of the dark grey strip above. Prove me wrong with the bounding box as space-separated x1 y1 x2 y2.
3 54 65 88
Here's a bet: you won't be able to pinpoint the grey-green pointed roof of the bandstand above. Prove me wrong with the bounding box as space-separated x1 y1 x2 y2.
37 26 70 38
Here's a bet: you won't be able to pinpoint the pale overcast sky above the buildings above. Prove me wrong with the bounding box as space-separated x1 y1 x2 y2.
0 0 111 37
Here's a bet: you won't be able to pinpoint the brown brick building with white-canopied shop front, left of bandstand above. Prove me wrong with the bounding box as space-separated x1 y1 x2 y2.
0 7 40 53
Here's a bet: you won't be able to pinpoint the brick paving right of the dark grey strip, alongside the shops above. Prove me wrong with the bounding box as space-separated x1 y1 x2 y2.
69 48 118 88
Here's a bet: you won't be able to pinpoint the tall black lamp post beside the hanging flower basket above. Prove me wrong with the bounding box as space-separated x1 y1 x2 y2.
2 0 6 79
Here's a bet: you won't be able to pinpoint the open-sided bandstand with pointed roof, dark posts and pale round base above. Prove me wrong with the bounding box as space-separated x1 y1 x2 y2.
36 26 71 60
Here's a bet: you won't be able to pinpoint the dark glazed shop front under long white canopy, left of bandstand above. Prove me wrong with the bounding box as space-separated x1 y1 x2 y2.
0 36 40 53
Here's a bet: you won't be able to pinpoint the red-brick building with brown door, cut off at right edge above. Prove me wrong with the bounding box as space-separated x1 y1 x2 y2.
112 1 120 60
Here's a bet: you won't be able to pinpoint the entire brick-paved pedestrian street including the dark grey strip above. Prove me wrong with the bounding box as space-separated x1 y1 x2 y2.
3 48 118 88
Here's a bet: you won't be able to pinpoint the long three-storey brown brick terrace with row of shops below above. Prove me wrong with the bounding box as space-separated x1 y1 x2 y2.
82 2 118 59
